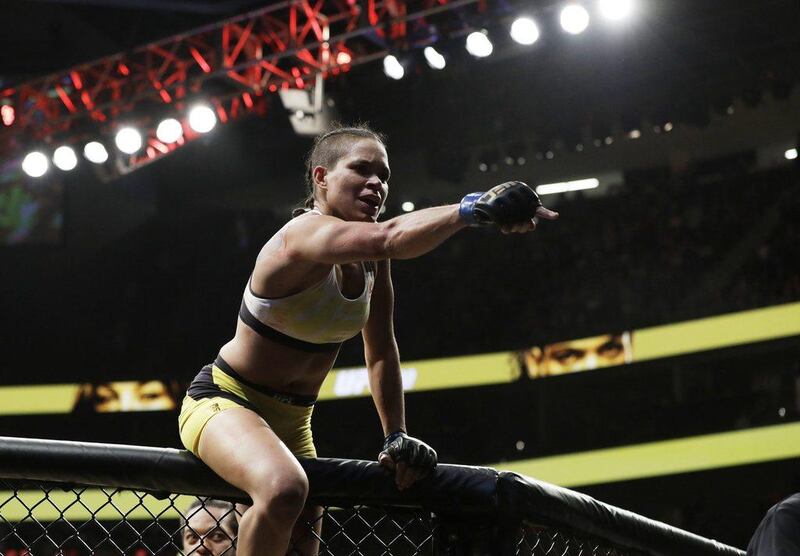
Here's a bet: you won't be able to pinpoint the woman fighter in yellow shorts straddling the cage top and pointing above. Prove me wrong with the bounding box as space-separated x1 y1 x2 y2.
179 122 558 556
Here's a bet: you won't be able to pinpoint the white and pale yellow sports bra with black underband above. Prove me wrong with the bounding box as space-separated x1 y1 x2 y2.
239 211 375 352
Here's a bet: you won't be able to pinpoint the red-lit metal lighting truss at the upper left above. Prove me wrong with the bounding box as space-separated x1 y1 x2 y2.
0 0 468 141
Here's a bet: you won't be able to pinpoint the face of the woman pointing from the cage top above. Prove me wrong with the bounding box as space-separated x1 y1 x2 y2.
315 138 389 222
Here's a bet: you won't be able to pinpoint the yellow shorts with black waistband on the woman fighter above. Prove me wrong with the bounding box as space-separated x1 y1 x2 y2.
178 357 317 458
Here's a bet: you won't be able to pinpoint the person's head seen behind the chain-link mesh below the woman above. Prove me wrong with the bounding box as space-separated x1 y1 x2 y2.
180 498 239 556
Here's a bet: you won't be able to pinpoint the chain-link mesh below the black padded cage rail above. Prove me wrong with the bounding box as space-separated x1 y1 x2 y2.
0 480 638 556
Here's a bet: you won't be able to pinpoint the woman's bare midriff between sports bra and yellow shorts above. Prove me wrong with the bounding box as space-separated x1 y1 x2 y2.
219 320 338 395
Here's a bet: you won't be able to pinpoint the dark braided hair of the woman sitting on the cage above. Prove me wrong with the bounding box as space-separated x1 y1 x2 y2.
292 123 386 217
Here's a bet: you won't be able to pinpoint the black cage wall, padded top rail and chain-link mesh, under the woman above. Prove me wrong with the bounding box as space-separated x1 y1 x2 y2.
0 438 744 556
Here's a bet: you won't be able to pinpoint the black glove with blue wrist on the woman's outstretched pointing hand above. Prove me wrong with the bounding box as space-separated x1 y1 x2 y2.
458 181 542 227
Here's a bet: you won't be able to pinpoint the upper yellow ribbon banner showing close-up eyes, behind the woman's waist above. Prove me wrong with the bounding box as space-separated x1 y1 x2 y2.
0 303 800 415
